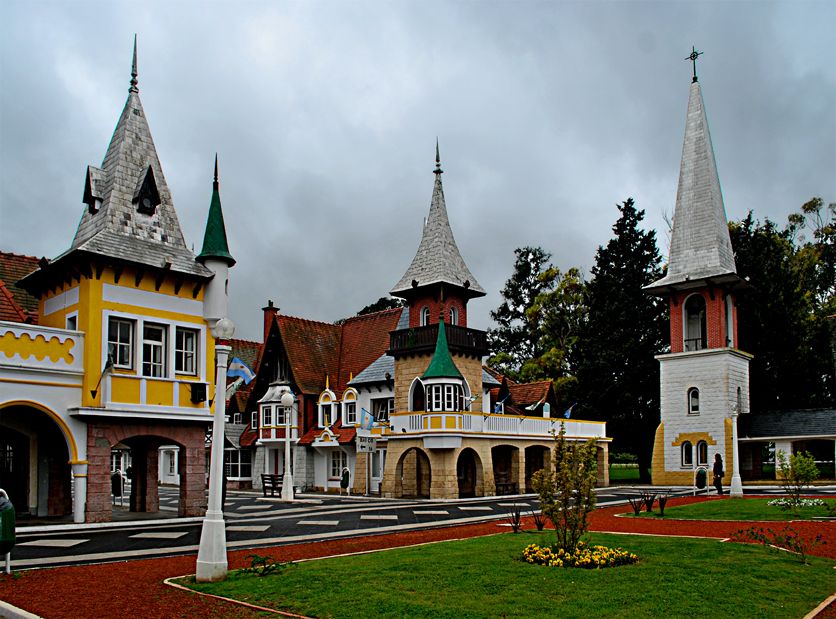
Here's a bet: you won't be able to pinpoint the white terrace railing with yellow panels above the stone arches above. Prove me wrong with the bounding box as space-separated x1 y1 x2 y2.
390 412 607 439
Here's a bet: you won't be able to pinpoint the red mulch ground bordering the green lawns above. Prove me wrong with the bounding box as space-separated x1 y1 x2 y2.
0 497 836 619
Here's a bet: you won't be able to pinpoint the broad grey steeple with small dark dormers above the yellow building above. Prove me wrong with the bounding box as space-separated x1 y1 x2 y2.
65 36 211 277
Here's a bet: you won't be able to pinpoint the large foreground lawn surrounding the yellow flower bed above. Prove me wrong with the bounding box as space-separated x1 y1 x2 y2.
182 531 836 619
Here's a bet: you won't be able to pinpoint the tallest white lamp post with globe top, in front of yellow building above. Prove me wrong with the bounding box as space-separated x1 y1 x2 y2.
195 318 235 582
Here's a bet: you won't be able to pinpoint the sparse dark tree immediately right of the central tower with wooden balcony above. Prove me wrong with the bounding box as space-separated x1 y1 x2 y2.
488 247 553 379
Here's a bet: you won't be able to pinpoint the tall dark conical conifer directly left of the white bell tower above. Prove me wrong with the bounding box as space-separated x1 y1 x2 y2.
576 198 669 481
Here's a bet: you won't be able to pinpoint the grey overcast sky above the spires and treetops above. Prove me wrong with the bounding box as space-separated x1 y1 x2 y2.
0 0 836 339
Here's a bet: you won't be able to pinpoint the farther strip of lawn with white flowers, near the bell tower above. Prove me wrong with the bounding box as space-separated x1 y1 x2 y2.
630 497 836 521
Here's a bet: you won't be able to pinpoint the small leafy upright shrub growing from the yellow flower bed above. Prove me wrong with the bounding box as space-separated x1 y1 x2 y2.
531 423 598 554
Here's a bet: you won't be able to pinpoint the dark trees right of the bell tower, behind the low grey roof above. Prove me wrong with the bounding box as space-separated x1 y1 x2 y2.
729 206 836 413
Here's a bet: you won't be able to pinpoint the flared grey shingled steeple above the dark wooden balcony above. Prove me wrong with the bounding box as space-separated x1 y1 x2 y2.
391 141 485 297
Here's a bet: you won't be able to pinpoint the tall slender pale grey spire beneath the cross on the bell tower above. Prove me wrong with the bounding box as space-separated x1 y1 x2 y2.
647 66 739 293
